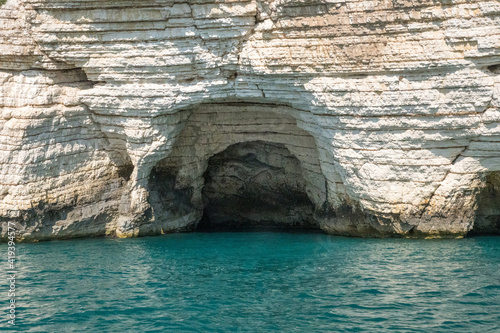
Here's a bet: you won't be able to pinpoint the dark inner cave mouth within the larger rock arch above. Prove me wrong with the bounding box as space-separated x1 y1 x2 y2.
197 141 319 231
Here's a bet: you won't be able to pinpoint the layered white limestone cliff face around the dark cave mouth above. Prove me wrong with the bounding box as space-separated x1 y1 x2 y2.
0 0 500 239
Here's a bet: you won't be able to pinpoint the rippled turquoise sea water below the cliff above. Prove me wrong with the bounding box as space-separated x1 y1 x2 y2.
0 232 500 332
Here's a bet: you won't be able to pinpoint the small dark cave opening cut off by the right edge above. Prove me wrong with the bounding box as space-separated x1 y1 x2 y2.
470 171 500 235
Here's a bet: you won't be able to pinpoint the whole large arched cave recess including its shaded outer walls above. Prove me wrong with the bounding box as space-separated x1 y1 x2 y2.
146 102 328 233
